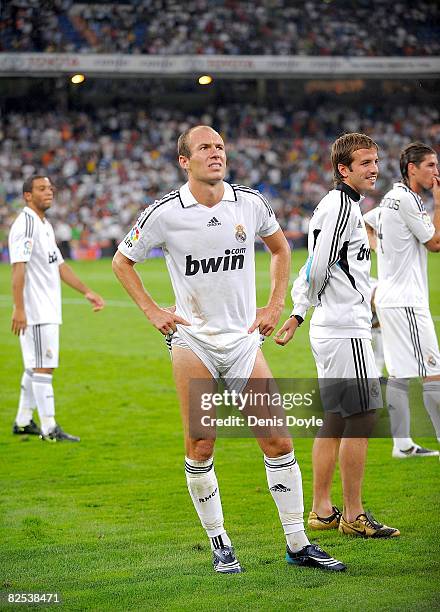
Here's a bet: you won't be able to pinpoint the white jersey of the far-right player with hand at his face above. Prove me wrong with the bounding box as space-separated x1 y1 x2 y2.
364 183 435 308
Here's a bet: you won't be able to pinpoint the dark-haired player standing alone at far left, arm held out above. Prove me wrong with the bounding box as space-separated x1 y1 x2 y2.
9 175 104 442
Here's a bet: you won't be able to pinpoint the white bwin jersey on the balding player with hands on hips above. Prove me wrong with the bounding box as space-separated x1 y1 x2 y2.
118 183 279 351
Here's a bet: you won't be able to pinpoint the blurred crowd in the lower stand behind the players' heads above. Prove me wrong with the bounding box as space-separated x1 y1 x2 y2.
0 104 440 256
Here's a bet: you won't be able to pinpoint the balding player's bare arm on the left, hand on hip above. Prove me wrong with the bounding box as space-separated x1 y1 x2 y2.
112 251 190 335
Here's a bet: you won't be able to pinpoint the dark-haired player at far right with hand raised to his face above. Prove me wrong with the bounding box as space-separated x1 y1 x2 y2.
364 142 440 459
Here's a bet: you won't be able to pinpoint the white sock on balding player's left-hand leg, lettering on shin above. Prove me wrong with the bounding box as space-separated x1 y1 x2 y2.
185 457 231 549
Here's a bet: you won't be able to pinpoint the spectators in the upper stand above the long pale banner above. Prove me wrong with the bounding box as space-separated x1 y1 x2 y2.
0 0 440 56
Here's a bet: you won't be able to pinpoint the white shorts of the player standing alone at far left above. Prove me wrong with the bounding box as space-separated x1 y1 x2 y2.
20 323 60 369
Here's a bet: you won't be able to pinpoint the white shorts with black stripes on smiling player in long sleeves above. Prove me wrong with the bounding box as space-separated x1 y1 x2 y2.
310 338 383 417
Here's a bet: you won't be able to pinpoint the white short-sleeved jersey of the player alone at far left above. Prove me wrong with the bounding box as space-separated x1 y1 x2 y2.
9 206 64 325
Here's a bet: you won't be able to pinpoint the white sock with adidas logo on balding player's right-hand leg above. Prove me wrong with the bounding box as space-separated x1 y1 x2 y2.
264 451 310 552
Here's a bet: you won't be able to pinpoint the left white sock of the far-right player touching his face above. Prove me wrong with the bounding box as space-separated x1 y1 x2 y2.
386 378 415 451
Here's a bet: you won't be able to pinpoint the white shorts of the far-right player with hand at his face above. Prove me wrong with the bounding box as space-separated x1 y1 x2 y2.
377 307 440 378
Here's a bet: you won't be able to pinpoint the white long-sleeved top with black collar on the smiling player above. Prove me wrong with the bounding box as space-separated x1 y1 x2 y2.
292 183 371 338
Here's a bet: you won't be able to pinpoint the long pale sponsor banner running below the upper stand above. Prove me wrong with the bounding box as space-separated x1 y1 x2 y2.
0 53 440 78
